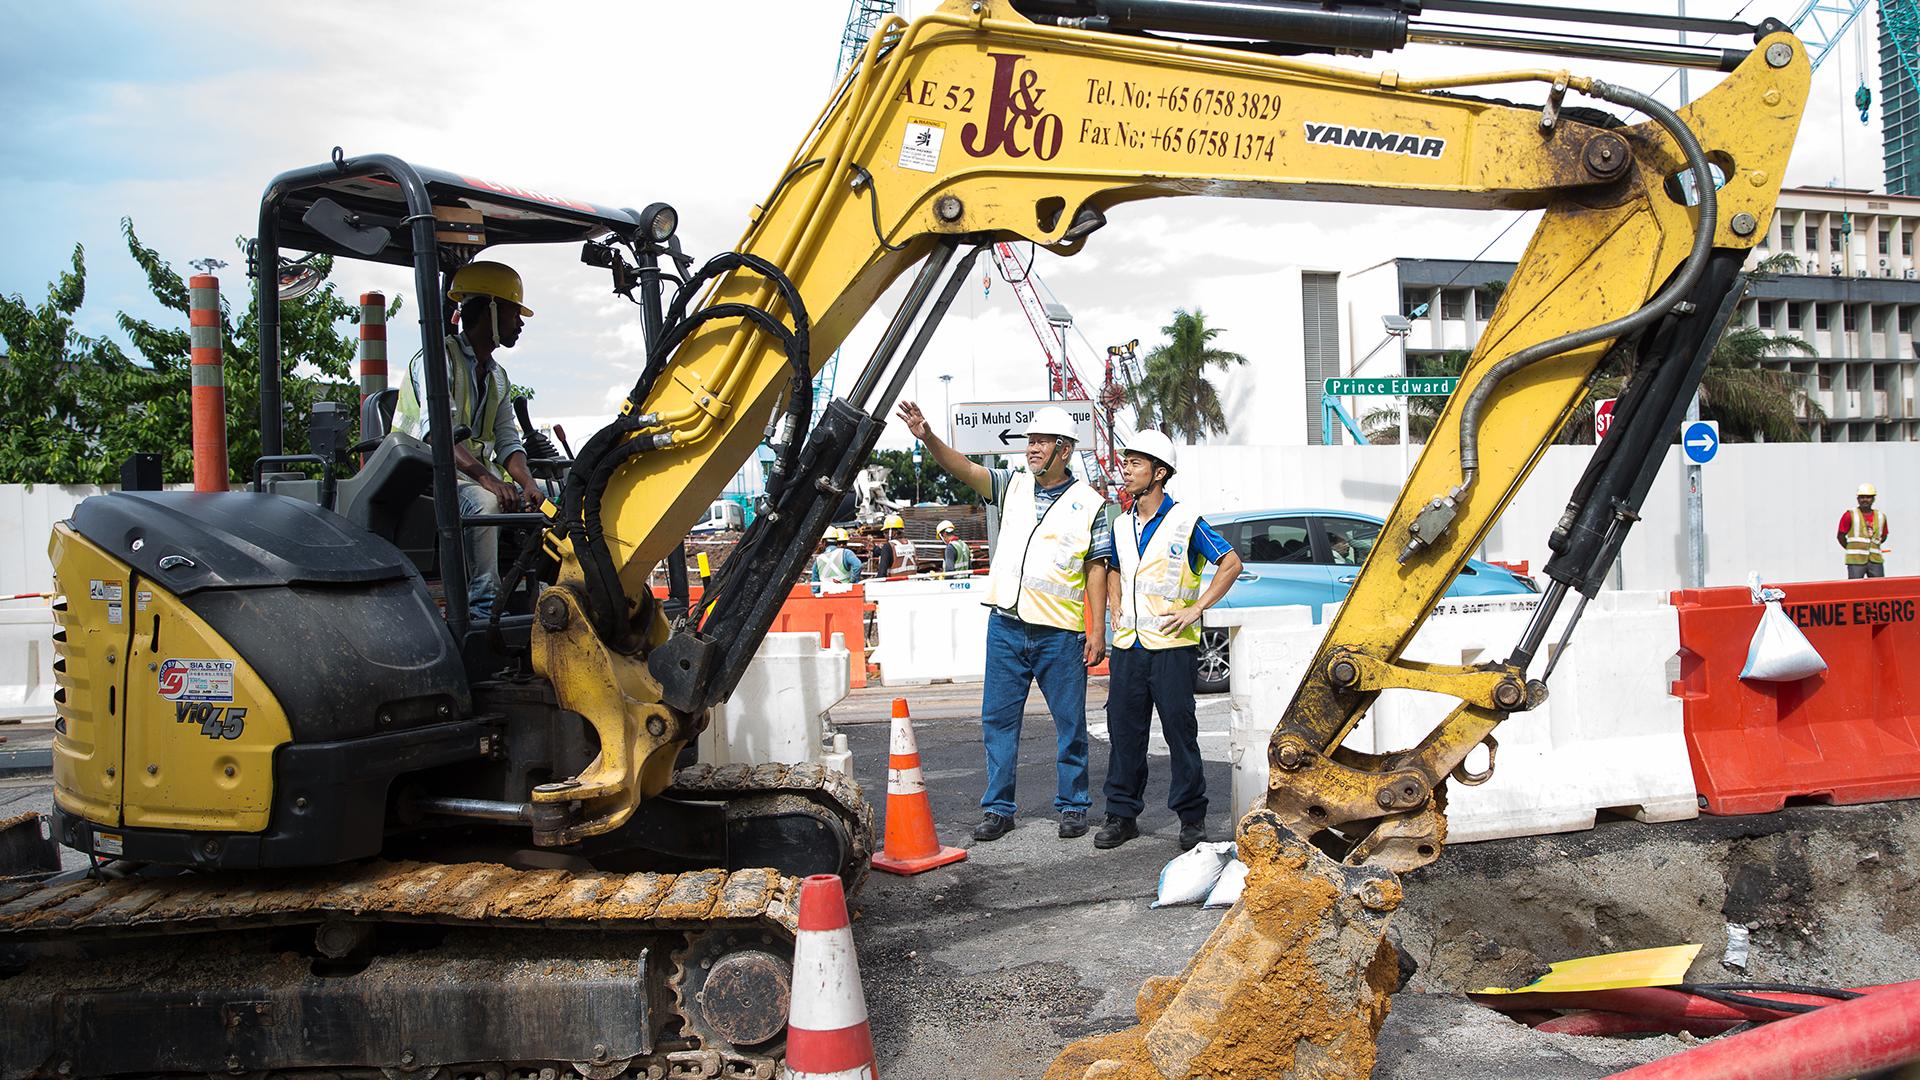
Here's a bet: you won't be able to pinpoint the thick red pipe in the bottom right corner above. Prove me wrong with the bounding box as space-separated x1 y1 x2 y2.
1615 984 1920 1080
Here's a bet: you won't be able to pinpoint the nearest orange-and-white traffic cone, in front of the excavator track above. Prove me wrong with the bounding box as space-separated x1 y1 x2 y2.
787 874 877 1080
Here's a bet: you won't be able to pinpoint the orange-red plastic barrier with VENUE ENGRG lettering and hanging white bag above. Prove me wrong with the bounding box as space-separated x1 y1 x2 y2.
1672 578 1920 815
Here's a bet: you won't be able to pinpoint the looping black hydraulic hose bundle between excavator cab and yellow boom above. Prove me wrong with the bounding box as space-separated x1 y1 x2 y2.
555 252 812 653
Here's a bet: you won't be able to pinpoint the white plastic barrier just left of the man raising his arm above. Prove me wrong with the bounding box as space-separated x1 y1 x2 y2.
866 577 987 686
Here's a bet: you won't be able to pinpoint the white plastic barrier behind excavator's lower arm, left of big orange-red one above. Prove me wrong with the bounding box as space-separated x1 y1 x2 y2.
1231 592 1699 844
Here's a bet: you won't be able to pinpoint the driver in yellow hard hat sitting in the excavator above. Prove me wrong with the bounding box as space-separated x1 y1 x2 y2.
394 259 545 619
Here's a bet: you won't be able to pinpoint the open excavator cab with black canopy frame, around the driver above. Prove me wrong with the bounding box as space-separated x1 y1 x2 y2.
252 150 685 657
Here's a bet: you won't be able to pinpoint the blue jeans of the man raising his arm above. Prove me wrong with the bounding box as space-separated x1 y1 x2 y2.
979 611 1092 817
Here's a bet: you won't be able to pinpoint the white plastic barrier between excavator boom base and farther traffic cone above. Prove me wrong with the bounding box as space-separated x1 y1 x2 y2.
697 632 852 776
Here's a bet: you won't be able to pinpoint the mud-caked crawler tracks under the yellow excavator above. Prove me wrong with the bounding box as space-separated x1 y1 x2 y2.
0 765 872 1080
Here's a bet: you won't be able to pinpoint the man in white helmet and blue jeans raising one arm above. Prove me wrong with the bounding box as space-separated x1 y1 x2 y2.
900 402 1114 840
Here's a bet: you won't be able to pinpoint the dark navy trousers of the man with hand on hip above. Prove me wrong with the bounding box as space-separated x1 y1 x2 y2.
1106 646 1206 824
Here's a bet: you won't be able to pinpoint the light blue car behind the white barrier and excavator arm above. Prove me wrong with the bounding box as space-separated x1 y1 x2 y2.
1194 509 1540 694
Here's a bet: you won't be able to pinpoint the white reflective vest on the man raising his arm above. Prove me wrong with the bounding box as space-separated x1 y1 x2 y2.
985 473 1106 632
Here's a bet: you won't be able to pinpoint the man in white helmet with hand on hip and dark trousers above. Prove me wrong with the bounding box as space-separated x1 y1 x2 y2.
1092 430 1240 851
